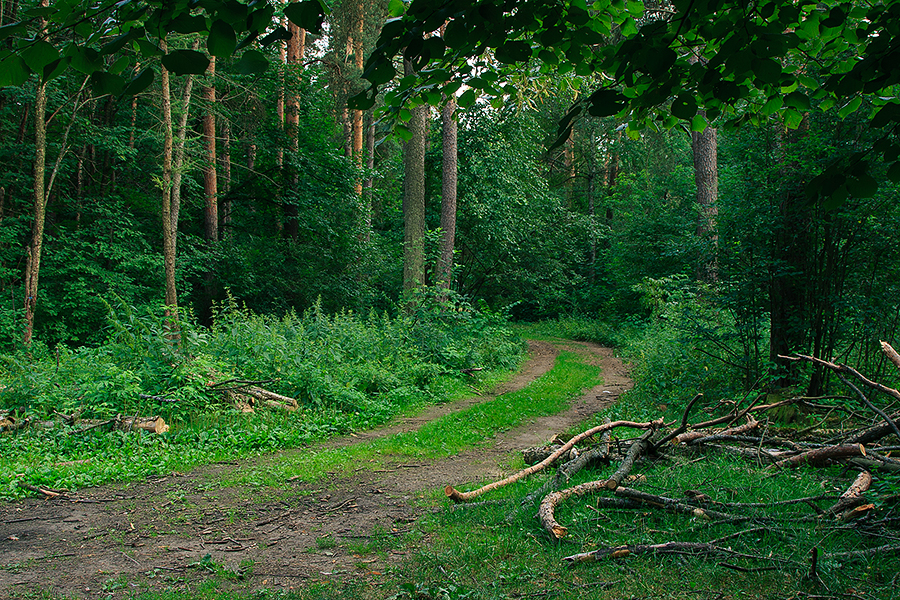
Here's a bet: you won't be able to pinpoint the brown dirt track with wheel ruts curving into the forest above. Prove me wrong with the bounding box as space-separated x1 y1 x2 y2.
0 342 631 598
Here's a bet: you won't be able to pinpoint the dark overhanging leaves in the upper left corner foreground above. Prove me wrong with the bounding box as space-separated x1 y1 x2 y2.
0 0 325 96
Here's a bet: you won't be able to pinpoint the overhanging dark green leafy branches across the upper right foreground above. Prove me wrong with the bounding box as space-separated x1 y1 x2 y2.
353 0 900 203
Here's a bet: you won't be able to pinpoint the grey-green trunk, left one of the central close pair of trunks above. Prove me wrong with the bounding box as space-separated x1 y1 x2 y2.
403 61 428 300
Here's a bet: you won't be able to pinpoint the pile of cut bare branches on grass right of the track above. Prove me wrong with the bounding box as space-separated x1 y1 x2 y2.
445 342 900 576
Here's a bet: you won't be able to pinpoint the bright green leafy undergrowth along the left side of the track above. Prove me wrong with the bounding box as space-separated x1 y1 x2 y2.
0 292 524 499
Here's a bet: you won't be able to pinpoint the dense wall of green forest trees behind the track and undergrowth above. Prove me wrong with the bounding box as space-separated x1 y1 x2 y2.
0 1 900 404
